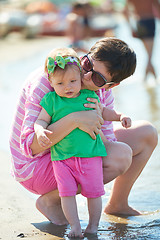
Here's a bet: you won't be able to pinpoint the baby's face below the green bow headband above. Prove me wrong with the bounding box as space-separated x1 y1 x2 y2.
50 66 81 98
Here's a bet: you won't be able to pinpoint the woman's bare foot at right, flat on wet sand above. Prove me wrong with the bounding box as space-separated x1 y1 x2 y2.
104 204 142 216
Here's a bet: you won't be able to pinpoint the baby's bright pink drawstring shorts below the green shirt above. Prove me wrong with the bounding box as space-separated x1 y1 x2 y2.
52 157 105 198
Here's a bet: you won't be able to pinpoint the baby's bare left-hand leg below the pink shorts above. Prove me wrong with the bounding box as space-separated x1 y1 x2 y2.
61 196 83 238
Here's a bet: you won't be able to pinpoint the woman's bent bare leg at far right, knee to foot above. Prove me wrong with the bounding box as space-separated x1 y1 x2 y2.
104 121 158 215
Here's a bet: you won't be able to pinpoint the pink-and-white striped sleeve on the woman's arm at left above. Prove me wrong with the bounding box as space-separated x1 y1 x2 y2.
20 69 51 158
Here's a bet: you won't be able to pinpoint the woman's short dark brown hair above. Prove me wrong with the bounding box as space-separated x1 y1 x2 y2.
89 37 136 83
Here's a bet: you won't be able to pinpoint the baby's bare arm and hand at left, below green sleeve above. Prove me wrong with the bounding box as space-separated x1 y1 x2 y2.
34 108 52 147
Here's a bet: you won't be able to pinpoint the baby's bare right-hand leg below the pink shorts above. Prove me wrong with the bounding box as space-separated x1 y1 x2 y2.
85 197 102 234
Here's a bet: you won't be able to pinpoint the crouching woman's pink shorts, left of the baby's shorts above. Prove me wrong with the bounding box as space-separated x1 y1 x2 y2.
20 153 57 195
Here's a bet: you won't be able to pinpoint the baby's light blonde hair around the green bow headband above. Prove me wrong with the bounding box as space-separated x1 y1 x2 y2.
44 47 80 77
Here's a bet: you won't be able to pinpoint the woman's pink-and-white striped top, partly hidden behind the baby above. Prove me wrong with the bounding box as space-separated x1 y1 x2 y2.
10 68 116 182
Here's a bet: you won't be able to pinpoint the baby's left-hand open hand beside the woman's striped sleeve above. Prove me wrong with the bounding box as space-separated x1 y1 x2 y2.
37 129 52 148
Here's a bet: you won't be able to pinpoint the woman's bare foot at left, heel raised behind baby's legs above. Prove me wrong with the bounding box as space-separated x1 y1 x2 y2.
36 191 68 225
